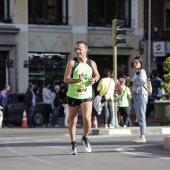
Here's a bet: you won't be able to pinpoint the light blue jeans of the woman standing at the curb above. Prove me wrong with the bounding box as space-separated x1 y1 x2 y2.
134 94 148 135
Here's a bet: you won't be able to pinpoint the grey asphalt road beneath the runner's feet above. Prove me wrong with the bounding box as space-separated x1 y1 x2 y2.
0 128 170 170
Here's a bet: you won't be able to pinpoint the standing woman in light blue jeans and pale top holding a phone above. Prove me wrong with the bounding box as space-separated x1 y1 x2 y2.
124 56 148 143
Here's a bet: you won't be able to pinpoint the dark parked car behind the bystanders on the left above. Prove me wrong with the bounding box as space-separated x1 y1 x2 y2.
8 93 44 126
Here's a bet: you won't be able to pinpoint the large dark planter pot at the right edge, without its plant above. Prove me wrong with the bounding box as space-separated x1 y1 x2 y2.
154 102 170 125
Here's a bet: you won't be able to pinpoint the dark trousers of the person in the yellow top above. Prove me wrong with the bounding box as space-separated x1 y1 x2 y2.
104 100 113 125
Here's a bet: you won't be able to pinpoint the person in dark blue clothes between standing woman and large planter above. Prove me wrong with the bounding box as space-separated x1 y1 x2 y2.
146 69 163 119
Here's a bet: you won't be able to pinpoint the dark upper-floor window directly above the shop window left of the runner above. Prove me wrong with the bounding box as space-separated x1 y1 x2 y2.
28 0 68 25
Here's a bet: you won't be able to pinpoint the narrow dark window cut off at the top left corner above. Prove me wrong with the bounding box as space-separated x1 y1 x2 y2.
0 0 12 23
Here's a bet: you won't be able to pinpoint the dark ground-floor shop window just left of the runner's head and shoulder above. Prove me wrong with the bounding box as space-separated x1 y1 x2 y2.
28 53 67 89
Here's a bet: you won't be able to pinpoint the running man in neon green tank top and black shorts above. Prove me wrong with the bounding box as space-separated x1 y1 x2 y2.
64 41 100 155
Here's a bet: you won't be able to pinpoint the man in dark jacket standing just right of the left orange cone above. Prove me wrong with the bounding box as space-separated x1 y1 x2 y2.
24 83 36 127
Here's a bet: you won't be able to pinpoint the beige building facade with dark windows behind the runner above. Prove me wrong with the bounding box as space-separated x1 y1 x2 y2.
0 0 167 92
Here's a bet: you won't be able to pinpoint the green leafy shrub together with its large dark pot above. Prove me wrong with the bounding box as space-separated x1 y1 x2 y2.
154 56 170 125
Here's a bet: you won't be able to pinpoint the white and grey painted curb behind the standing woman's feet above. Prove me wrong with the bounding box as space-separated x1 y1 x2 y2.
91 126 170 135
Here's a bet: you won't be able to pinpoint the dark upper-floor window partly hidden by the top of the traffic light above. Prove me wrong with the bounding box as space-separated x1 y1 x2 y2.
88 0 131 27
